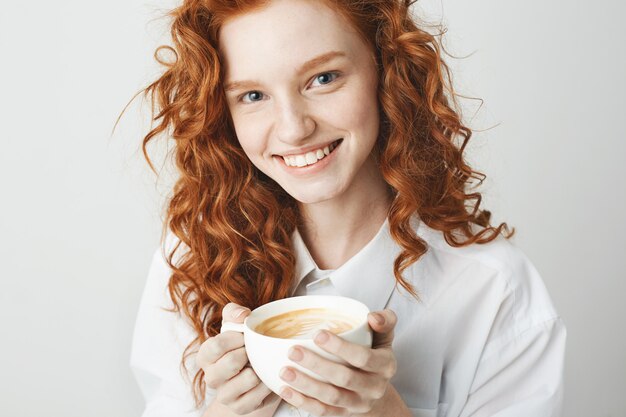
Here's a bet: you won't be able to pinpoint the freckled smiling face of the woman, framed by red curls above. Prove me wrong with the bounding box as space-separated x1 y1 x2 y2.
219 0 379 204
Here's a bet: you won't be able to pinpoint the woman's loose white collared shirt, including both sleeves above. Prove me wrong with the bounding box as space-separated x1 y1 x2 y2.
131 221 566 417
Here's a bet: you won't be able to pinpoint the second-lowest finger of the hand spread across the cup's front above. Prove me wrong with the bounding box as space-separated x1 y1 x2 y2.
280 367 369 413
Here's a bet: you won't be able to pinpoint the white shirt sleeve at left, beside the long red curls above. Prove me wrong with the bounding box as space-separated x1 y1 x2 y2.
130 240 209 417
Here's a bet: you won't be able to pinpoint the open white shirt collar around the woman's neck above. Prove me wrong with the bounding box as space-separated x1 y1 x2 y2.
292 219 401 311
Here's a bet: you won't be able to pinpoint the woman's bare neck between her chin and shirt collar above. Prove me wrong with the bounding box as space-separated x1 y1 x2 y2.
299 157 392 269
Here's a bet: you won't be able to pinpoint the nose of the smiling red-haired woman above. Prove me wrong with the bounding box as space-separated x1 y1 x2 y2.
275 94 316 145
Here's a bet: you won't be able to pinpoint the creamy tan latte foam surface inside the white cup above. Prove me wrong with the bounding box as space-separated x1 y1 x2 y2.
254 308 359 339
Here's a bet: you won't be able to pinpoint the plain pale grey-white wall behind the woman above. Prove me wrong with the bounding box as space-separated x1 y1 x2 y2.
0 0 626 417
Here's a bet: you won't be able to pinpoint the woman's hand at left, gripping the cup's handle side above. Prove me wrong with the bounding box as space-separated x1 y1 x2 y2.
196 303 278 414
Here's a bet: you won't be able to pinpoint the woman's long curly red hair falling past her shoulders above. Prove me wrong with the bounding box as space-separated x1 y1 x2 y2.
134 0 513 407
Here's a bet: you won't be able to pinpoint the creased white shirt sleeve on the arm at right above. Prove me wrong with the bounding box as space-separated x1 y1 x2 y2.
460 244 566 417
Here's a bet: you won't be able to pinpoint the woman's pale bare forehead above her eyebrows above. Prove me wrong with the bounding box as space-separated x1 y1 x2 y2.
219 0 365 79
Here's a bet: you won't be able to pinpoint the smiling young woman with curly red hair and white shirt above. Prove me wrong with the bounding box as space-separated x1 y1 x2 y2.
131 0 565 417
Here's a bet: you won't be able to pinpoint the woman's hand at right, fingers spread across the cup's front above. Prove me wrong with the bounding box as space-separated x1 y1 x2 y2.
280 310 406 416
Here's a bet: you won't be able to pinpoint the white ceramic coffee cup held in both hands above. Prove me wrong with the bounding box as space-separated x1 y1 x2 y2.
221 295 372 394
